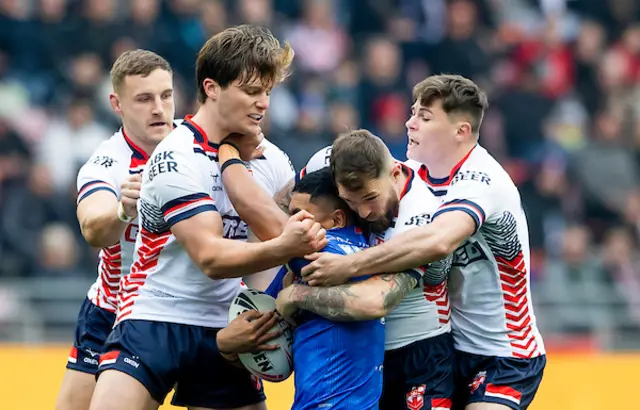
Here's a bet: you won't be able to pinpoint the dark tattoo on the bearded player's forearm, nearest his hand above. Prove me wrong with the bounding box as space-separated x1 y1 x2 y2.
294 284 358 321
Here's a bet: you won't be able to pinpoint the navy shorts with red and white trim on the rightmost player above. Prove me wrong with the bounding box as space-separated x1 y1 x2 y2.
454 351 547 410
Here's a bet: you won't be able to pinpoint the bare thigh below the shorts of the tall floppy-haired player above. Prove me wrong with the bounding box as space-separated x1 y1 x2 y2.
90 370 160 410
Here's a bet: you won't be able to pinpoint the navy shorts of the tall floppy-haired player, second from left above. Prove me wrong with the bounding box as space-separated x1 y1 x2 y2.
98 319 265 409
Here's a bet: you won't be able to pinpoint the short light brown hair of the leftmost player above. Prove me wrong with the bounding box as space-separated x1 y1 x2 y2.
111 49 173 93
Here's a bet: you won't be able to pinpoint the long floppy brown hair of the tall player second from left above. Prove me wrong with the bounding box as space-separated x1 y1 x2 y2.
196 24 294 103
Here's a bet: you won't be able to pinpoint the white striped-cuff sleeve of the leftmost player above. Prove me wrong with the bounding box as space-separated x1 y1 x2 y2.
76 148 121 203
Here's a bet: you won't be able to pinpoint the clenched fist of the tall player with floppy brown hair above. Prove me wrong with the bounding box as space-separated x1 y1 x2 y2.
280 211 327 258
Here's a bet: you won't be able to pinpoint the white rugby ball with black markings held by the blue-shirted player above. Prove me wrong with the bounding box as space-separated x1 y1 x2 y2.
229 288 293 382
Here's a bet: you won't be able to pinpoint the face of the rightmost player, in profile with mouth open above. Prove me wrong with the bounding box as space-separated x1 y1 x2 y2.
405 100 459 163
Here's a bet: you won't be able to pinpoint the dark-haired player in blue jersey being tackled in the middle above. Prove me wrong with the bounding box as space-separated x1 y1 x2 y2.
218 168 392 410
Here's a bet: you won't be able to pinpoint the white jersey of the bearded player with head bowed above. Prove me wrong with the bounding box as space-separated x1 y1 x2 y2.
370 164 451 350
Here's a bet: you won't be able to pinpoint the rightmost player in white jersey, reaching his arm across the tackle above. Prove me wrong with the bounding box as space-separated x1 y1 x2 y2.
303 75 546 410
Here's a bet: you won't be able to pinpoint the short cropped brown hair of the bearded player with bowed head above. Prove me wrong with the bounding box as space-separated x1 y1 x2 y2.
331 130 393 191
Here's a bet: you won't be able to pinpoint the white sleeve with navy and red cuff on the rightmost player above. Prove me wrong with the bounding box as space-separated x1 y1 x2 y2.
433 170 505 232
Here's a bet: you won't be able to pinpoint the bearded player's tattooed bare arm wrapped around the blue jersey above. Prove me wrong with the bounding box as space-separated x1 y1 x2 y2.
276 273 418 321
